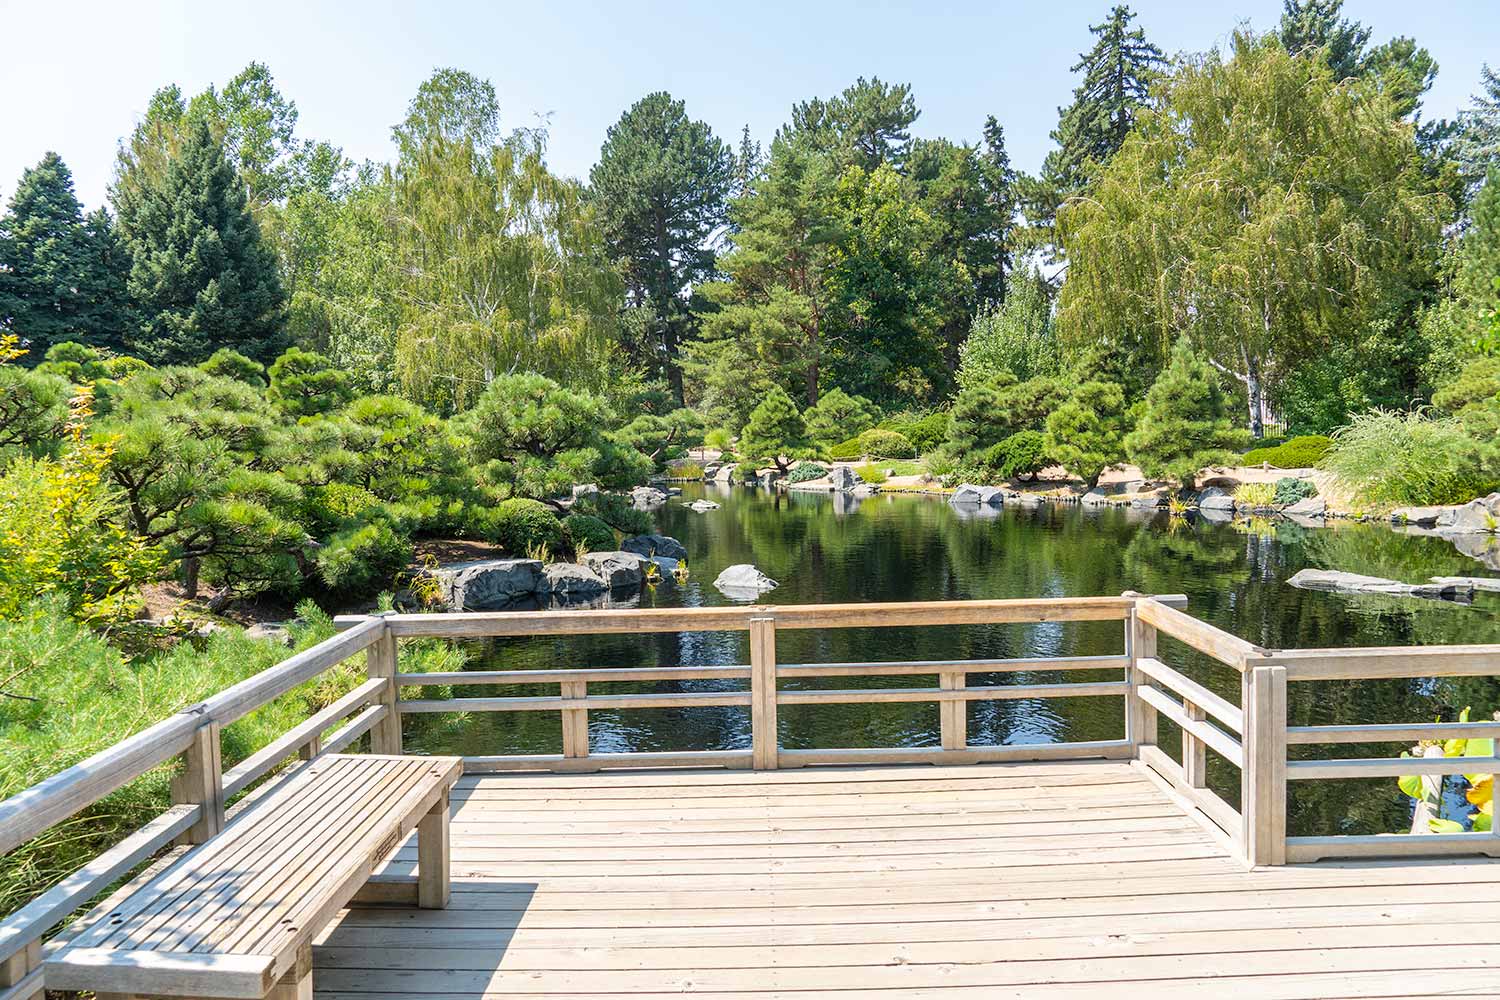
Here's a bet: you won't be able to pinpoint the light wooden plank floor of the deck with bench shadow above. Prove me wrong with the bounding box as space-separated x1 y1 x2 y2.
314 762 1500 1000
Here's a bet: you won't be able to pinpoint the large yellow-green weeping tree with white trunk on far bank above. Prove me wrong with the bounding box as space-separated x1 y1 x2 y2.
1056 33 1449 433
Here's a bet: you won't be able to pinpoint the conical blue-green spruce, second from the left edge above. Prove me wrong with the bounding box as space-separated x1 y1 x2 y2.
120 121 285 364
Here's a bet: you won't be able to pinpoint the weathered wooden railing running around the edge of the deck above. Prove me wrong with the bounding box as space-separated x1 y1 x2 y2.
0 594 1500 1000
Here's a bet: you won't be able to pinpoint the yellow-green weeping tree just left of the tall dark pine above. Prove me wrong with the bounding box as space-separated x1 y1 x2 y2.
392 132 623 409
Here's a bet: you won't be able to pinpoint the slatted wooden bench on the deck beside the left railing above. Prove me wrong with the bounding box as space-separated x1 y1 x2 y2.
47 754 464 1000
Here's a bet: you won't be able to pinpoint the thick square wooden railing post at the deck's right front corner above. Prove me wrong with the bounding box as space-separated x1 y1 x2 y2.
1241 664 1287 865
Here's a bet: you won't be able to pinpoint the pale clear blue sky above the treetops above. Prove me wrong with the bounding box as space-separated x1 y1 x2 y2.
0 0 1500 207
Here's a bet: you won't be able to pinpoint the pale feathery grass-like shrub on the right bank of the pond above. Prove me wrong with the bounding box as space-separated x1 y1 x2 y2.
1323 409 1500 505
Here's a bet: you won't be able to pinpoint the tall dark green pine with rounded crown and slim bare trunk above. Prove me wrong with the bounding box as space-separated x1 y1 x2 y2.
590 91 735 403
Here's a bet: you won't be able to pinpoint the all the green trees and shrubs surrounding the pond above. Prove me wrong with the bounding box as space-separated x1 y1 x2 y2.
0 0 1500 910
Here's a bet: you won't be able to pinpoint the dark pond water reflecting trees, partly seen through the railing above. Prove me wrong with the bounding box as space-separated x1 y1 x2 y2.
407 484 1500 835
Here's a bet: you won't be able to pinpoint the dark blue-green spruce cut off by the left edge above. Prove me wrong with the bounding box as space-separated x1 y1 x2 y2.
0 153 126 361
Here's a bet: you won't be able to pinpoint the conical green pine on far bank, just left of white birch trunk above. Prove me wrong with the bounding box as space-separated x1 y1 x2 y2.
1125 337 1250 490
